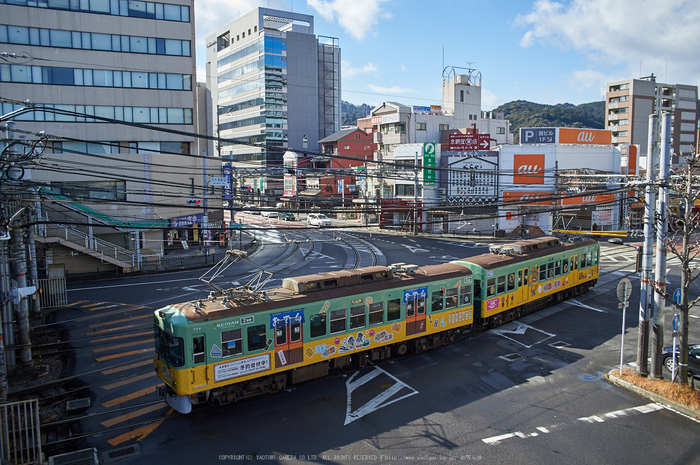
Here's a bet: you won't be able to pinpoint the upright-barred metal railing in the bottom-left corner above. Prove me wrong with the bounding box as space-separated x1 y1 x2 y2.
0 399 41 465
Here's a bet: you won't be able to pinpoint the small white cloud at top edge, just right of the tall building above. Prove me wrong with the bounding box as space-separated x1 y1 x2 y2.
306 0 391 40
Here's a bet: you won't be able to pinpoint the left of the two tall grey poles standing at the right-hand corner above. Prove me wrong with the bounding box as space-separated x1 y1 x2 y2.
637 114 656 375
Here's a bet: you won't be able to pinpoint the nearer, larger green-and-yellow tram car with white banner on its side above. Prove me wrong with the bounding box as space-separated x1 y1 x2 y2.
154 263 473 413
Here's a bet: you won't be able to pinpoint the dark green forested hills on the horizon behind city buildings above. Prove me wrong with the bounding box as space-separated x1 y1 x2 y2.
341 100 605 143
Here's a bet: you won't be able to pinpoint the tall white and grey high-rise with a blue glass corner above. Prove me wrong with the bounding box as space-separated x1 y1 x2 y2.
206 8 341 200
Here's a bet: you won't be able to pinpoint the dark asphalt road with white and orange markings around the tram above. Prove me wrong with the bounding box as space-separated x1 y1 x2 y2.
54 231 700 464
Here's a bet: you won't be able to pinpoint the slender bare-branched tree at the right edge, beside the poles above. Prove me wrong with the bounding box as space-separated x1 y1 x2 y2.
656 153 700 385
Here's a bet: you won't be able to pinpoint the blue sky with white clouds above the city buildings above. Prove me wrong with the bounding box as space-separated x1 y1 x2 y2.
195 0 700 110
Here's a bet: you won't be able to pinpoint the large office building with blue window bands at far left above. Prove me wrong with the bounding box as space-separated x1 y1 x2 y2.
0 0 211 273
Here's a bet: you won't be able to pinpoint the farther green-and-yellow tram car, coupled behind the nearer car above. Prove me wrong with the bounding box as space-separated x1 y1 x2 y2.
453 237 600 327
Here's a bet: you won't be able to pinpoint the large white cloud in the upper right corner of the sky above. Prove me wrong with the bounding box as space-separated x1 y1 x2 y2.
516 0 700 84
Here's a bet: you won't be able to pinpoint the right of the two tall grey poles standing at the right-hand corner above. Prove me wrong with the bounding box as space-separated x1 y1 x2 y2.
650 112 671 379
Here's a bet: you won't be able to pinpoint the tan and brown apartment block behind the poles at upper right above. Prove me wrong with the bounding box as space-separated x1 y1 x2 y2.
605 74 698 167
